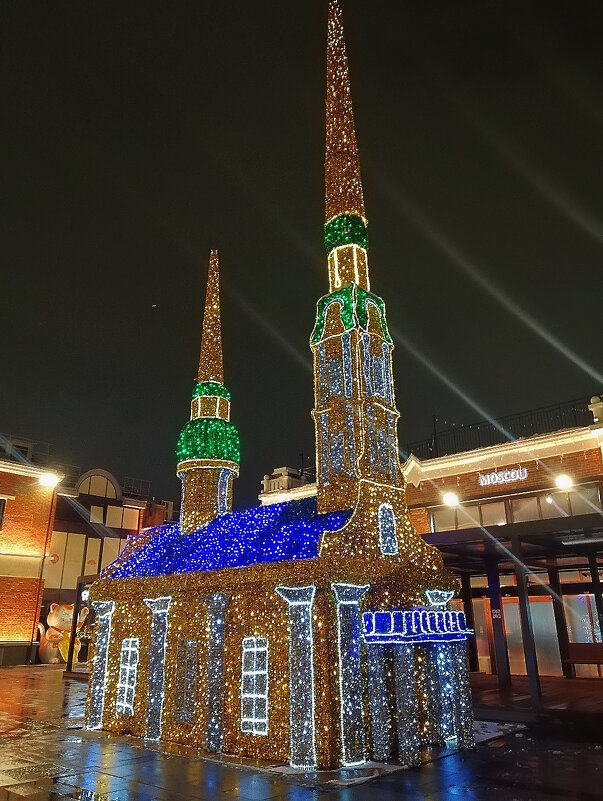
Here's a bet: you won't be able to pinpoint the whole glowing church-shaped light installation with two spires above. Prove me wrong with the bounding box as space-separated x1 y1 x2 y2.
87 0 473 770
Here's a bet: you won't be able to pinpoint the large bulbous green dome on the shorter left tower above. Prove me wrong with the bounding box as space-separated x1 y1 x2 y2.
176 418 241 464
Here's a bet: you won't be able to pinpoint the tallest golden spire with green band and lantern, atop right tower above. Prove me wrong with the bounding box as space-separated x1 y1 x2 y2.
324 0 370 292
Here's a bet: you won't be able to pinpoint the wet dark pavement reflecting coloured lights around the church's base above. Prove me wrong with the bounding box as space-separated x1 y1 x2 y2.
0 666 603 801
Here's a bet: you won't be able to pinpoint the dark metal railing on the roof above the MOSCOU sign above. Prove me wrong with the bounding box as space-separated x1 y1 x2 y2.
400 397 593 459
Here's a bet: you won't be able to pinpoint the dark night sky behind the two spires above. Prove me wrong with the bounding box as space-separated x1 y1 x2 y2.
0 0 603 506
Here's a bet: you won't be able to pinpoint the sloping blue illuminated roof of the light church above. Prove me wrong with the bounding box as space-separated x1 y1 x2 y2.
102 498 352 579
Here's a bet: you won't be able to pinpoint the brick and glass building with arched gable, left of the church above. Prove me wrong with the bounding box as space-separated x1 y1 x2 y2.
0 436 173 665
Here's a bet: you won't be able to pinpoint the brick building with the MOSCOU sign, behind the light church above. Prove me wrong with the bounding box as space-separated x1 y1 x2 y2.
260 396 603 705
